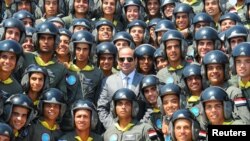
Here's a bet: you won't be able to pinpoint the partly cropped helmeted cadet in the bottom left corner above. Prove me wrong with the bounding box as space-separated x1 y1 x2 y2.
0 122 14 141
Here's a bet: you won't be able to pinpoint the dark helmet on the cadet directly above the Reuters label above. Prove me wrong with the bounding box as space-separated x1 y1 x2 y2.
200 86 233 120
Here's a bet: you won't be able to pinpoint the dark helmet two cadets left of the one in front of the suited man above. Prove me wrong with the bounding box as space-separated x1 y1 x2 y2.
38 88 66 118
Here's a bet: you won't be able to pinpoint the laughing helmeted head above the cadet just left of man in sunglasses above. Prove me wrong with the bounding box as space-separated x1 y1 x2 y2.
93 20 116 44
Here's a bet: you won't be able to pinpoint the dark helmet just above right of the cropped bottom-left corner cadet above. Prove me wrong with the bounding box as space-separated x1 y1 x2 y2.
3 93 35 126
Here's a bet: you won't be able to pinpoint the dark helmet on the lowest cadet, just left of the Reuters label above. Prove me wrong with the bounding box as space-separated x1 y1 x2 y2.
169 109 201 141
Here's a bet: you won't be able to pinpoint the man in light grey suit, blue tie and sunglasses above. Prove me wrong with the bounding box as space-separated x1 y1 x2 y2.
97 47 143 129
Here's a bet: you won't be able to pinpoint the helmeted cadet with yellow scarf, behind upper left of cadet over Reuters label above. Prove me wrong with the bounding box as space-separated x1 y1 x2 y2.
182 63 204 108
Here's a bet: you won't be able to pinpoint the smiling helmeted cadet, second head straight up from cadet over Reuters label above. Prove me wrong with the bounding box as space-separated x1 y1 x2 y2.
193 27 222 64
